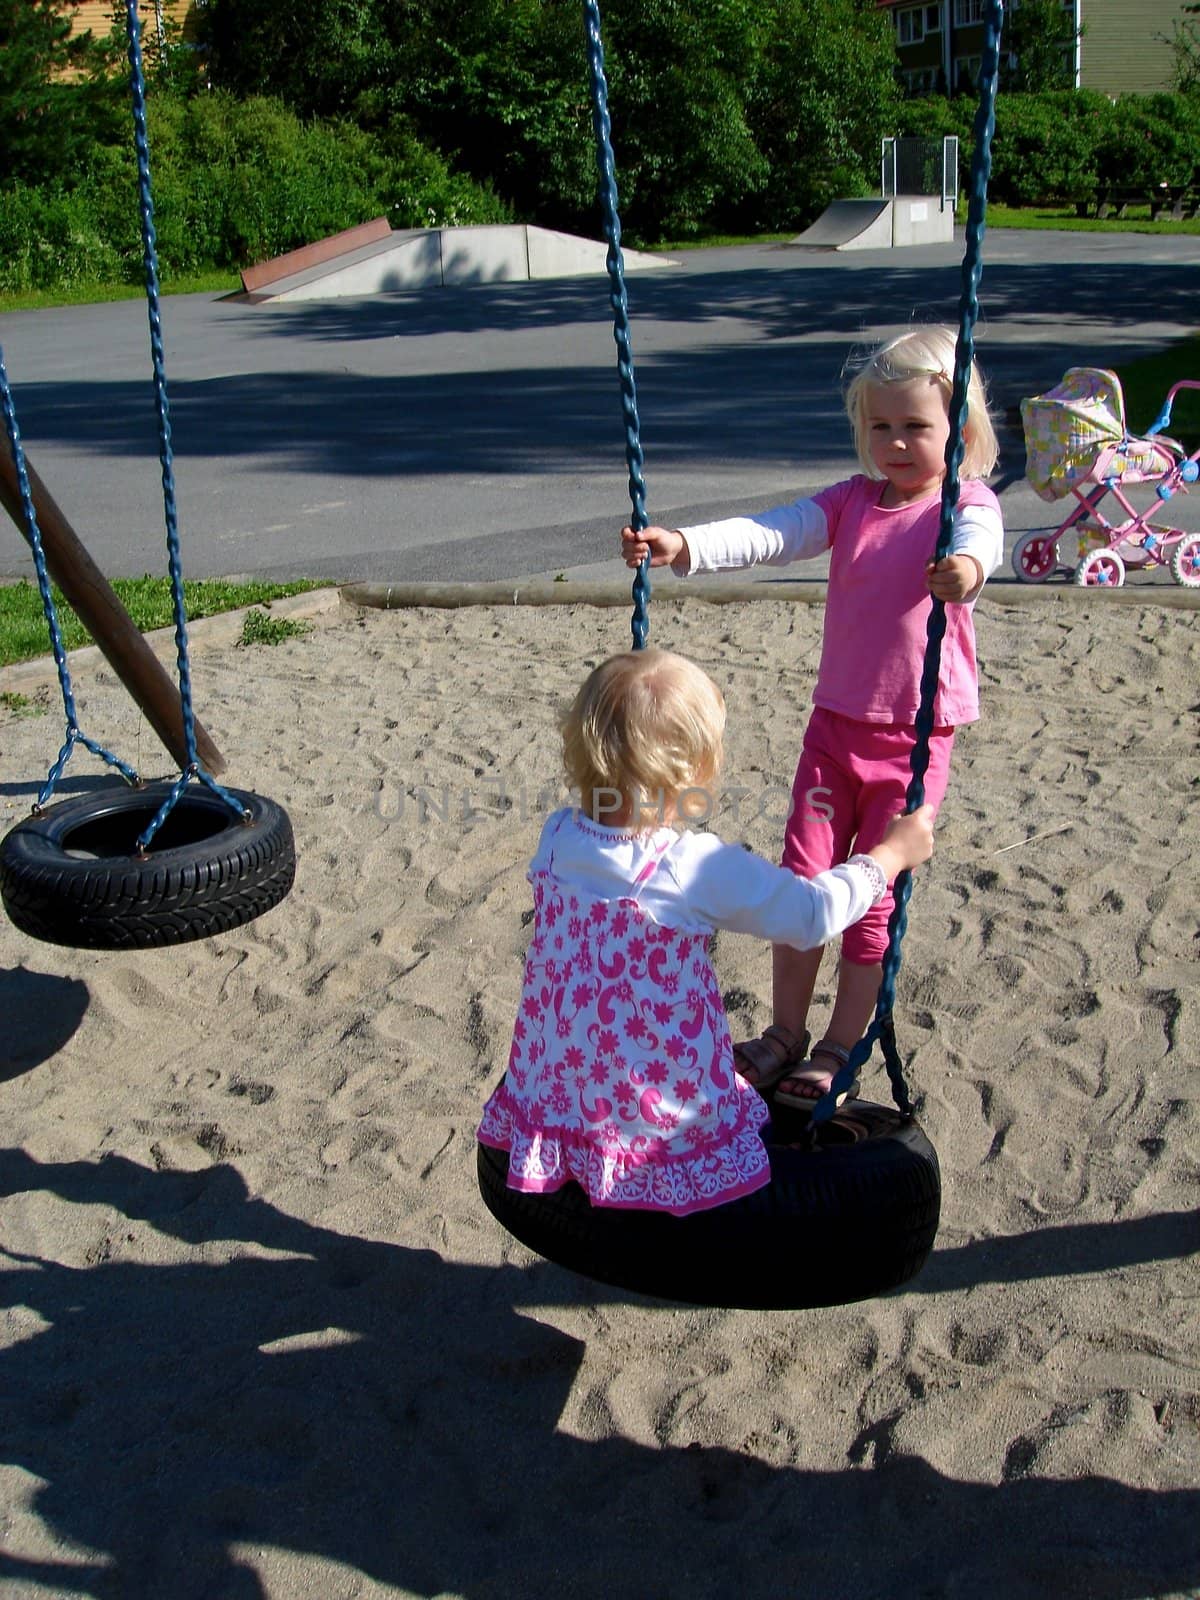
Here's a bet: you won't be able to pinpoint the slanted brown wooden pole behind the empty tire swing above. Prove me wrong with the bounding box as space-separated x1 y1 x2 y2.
0 450 226 776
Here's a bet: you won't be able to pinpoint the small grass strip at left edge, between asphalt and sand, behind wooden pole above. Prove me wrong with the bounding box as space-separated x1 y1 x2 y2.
0 578 322 667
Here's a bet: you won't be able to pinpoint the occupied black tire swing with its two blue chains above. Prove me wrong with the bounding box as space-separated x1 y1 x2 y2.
477 0 1003 1310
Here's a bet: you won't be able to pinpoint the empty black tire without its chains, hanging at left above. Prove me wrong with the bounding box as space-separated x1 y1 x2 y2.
0 782 296 950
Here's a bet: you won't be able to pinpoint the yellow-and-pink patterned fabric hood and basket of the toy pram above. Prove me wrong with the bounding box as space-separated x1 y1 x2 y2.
1021 366 1176 501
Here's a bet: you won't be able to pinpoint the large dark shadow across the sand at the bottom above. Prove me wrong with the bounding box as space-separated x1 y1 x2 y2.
0 1150 1200 1600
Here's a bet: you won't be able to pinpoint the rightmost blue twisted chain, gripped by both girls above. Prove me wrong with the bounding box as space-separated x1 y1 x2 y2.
811 0 1003 1125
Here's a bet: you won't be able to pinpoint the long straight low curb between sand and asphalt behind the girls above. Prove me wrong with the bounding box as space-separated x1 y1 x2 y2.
341 578 1200 611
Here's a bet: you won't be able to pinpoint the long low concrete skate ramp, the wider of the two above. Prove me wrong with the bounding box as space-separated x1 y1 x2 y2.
243 222 677 301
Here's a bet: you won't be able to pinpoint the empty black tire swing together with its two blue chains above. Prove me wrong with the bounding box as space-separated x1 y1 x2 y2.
0 0 296 950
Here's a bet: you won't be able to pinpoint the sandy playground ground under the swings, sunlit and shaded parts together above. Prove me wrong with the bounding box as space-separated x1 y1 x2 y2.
0 590 1200 1600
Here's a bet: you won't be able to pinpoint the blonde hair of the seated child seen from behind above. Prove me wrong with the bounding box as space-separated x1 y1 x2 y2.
562 650 725 818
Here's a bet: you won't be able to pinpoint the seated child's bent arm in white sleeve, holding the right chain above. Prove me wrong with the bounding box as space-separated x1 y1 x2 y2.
672 805 933 950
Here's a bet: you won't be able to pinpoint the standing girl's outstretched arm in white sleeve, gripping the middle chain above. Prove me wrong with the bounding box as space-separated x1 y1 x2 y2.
621 499 829 578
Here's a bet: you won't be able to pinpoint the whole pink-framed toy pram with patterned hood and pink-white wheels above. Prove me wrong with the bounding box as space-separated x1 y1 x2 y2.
1013 366 1200 589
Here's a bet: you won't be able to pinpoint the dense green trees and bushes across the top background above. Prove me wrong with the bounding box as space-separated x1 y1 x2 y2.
0 0 1200 297
